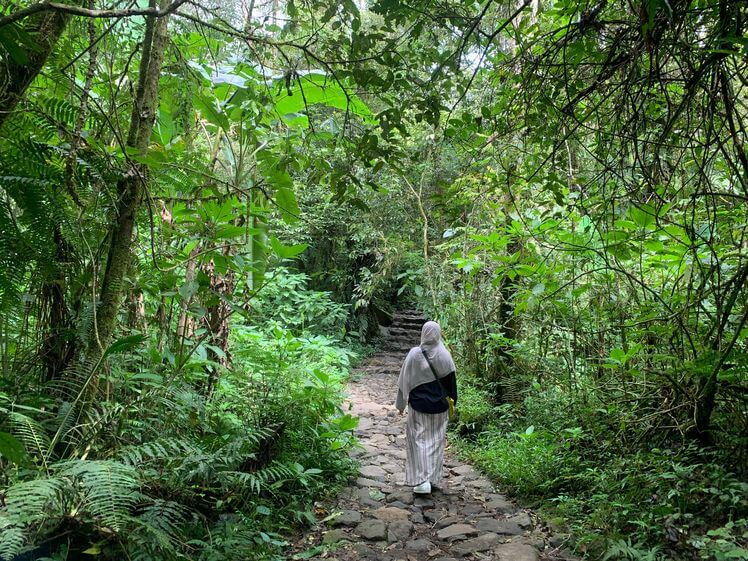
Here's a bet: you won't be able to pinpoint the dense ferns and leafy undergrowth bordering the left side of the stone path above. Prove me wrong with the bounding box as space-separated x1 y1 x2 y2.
0 273 357 561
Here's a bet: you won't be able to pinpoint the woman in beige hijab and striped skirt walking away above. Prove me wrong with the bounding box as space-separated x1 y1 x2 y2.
395 321 457 494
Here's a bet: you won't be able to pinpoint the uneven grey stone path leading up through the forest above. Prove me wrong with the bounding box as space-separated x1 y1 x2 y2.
295 312 569 561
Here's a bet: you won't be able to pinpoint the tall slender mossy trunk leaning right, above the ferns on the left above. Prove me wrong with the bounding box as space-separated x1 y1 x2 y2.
87 0 169 358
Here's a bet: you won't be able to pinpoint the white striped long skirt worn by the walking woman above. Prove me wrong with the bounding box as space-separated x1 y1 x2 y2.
405 407 449 486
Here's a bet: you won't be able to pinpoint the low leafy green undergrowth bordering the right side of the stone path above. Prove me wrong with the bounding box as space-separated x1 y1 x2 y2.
454 379 748 561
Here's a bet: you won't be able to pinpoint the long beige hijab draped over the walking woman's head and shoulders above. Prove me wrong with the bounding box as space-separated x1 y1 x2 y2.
395 321 456 411
